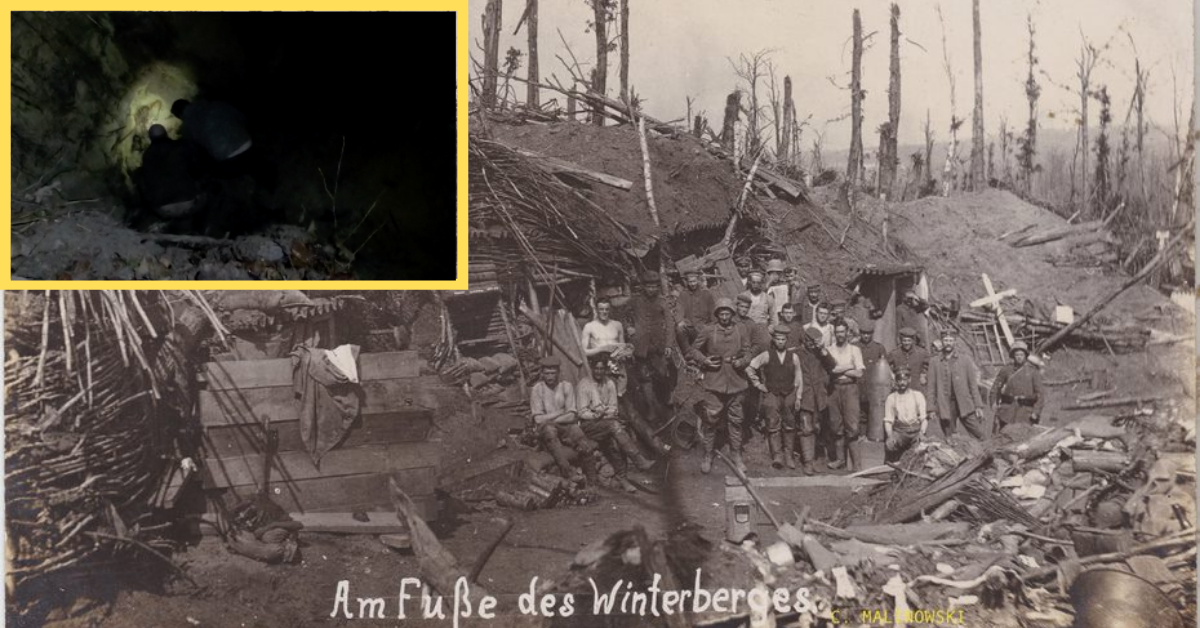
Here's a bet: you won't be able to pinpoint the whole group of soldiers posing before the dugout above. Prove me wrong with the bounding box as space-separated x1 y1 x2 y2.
530 261 1044 485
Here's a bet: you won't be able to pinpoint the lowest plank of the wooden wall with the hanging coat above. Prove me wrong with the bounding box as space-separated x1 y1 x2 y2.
228 467 437 513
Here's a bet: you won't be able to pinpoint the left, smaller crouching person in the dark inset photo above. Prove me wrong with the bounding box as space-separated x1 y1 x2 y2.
133 125 204 220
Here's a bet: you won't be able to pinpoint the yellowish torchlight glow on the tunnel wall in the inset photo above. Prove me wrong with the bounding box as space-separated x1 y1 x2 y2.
109 61 199 189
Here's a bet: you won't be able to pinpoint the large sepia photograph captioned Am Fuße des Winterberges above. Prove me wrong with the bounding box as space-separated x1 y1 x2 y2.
4 0 1198 628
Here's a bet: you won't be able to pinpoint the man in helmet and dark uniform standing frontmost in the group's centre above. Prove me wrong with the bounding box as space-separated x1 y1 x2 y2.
689 298 750 473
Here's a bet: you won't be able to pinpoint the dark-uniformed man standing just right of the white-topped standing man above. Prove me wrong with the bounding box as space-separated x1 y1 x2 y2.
625 271 676 425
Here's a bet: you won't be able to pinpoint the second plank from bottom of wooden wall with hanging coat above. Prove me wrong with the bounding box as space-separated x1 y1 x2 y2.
204 442 440 489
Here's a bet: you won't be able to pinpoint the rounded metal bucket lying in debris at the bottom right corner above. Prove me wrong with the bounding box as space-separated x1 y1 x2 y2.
1070 569 1183 628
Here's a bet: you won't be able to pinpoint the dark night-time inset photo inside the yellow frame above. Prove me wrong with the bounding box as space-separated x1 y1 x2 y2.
11 7 458 281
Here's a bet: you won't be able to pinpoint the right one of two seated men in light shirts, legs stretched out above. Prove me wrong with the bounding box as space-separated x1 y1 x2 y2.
576 353 654 471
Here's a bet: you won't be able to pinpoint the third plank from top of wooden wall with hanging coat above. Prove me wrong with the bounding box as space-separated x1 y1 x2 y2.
204 409 433 457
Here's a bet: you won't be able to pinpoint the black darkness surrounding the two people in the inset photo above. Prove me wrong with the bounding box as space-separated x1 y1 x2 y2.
13 12 457 280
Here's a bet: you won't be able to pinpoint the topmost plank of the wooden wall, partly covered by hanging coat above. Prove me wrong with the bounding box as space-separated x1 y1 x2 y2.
203 351 422 390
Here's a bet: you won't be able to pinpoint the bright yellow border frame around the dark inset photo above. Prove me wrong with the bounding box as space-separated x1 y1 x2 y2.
0 0 469 291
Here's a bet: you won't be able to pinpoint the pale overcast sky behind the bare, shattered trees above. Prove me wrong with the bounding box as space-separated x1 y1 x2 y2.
469 0 1194 150
